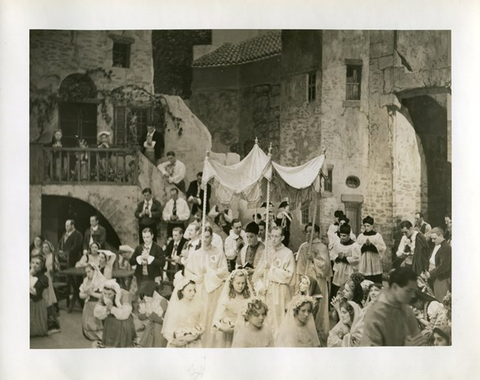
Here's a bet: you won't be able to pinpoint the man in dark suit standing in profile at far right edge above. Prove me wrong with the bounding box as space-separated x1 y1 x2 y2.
426 227 452 302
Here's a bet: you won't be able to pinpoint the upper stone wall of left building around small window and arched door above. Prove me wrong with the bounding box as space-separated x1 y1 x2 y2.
30 30 153 142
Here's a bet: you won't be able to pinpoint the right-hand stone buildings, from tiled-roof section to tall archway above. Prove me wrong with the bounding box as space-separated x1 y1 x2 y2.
191 30 451 267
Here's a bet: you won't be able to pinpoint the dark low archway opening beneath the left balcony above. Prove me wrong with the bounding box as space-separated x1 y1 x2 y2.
42 195 121 249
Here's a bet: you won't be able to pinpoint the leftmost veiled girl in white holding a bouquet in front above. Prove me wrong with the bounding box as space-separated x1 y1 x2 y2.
162 278 205 348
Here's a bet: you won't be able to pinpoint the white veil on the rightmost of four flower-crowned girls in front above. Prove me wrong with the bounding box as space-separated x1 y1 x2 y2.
275 295 320 347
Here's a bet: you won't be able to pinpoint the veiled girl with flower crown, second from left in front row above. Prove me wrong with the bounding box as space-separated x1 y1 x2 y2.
213 269 255 348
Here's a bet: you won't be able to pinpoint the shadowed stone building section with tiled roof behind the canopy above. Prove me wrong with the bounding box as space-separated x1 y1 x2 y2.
189 31 281 155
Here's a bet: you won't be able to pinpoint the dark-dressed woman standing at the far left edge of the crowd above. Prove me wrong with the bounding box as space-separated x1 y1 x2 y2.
30 255 48 337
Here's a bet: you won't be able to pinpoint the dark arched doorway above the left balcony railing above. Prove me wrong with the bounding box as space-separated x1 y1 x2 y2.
58 74 98 147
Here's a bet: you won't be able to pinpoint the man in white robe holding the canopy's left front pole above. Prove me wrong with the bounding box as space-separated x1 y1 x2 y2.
185 227 229 347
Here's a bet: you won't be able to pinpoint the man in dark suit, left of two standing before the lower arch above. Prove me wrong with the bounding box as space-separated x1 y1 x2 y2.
58 219 83 313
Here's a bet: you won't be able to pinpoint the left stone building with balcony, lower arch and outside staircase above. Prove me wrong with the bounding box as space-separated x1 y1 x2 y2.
29 30 215 248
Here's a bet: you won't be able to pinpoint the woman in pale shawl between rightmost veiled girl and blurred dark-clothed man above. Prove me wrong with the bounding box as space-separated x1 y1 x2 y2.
327 300 364 347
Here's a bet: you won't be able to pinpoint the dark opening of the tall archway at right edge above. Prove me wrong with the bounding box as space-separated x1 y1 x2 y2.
400 90 452 226
